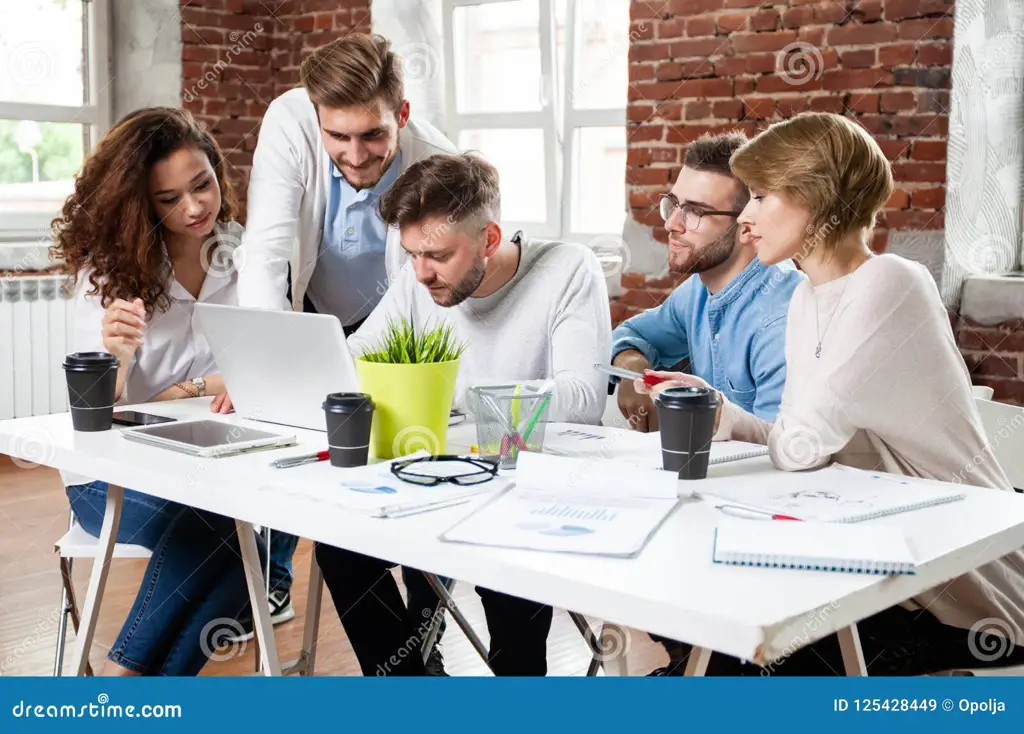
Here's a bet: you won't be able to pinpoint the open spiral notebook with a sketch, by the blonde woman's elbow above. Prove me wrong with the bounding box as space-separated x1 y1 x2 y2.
703 465 967 523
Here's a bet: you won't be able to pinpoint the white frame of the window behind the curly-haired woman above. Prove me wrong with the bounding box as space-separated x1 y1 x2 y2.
0 0 112 241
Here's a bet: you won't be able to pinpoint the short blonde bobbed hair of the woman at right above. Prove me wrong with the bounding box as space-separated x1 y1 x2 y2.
730 113 893 253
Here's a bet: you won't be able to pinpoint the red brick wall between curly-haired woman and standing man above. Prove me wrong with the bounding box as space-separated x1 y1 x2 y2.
181 0 370 221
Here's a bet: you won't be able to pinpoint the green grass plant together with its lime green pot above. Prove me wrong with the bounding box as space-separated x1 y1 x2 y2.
355 317 466 459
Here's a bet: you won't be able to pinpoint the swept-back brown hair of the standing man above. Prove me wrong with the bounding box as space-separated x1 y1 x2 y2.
299 33 406 112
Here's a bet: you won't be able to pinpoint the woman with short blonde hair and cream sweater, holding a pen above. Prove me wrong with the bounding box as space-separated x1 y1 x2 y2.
637 114 1024 675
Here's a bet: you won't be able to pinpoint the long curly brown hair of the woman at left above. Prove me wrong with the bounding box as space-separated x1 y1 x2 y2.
50 107 238 312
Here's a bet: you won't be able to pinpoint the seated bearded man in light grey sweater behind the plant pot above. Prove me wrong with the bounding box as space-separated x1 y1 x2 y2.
316 154 611 676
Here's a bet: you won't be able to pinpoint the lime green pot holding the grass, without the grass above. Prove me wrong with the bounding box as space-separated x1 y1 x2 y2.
355 357 459 459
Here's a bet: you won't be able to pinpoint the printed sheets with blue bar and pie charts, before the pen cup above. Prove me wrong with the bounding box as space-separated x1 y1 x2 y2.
441 452 679 558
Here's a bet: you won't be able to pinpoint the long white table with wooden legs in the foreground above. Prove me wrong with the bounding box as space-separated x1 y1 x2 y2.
6 399 1024 675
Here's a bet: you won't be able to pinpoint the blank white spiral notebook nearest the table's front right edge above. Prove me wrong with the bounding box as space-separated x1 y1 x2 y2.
713 517 916 575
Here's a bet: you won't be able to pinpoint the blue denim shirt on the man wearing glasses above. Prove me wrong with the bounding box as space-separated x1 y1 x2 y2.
611 257 805 421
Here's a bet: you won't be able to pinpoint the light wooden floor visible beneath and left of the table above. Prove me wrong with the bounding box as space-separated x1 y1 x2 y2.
0 456 667 676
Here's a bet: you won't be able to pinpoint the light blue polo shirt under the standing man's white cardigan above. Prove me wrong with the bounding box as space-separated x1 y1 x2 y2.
306 149 401 327
